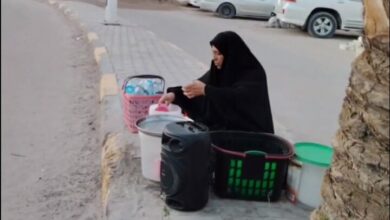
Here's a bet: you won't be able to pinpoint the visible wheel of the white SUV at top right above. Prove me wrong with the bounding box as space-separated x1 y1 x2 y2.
307 12 337 38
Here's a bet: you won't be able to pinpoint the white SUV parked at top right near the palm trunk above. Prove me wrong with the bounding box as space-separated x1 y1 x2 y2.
275 0 363 38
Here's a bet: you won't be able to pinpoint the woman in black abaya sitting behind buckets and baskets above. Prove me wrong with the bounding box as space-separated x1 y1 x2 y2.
159 31 274 133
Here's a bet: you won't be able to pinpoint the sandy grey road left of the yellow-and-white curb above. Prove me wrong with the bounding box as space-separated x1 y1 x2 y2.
1 0 100 220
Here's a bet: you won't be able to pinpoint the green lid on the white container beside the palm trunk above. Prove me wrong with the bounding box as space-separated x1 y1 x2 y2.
294 142 333 167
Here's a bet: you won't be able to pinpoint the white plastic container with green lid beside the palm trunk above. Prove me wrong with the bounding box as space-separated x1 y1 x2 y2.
287 142 333 208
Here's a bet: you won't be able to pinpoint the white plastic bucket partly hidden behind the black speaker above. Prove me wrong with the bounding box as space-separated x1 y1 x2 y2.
136 115 186 182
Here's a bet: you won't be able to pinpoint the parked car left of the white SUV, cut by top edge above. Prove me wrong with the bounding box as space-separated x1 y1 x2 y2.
200 0 276 18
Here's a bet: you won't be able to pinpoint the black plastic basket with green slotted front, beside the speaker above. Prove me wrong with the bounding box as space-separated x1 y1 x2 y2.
211 131 294 202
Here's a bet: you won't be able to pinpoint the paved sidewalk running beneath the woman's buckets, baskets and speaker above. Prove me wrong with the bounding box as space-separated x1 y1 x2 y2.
49 1 310 220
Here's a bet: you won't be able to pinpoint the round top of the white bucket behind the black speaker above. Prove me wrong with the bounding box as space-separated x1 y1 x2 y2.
136 115 186 137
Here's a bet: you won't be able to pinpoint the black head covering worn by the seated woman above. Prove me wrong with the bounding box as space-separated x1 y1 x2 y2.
210 31 265 86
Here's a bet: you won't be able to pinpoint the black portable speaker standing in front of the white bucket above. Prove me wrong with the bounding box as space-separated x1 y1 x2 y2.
160 121 211 211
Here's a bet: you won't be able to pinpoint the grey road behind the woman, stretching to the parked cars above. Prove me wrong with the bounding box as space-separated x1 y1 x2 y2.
119 5 356 145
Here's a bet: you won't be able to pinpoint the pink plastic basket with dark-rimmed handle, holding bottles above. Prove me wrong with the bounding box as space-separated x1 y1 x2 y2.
122 75 165 133
